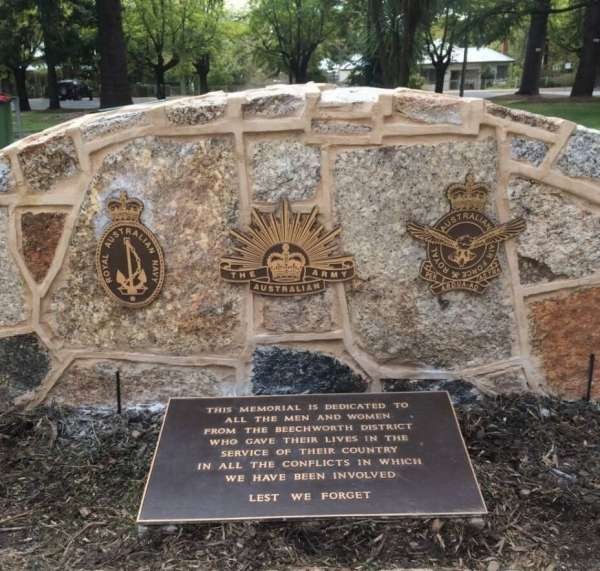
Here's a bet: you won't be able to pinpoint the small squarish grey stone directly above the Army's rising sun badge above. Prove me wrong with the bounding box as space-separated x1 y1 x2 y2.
248 139 321 202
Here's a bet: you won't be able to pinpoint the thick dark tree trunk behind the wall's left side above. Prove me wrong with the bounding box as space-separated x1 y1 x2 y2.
96 0 132 108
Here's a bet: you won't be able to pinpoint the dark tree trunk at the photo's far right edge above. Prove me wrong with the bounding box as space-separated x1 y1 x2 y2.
571 0 600 97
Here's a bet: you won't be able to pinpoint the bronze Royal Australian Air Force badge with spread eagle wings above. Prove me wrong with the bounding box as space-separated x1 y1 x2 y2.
406 174 525 295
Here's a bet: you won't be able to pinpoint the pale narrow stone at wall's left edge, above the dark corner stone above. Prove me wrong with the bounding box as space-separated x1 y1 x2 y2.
0 207 28 326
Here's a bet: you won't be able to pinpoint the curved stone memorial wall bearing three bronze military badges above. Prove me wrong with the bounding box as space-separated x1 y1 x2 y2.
0 84 600 407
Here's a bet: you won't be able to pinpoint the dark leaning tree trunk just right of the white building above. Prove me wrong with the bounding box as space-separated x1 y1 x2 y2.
517 0 551 95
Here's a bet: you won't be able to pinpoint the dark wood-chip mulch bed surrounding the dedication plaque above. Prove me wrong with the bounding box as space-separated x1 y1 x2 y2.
0 397 600 571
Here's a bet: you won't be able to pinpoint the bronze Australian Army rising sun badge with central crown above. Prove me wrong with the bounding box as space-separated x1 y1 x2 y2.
220 201 354 296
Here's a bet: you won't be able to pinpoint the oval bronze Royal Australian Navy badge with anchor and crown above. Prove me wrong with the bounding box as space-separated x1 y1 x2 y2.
96 192 165 308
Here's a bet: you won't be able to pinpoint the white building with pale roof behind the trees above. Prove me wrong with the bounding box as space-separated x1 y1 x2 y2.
419 47 515 91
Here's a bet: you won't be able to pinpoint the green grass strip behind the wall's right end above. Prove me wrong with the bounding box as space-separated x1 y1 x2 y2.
493 95 600 129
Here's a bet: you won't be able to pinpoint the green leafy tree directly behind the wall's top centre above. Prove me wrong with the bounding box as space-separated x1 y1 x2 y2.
250 0 338 83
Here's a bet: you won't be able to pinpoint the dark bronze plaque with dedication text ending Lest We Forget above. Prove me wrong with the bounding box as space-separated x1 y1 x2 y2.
138 392 487 524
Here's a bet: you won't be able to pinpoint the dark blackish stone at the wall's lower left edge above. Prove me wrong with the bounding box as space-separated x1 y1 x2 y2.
0 333 50 410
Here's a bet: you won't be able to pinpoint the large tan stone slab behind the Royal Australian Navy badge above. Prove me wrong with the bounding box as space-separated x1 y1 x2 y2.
46 137 242 354
